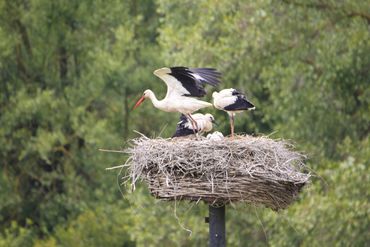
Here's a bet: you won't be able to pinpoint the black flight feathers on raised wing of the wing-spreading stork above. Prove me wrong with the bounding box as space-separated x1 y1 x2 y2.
170 67 221 97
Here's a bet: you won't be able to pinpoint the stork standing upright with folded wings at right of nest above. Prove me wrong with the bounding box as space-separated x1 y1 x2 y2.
212 88 255 138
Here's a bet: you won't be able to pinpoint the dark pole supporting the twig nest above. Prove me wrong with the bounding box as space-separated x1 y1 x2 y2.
208 205 226 247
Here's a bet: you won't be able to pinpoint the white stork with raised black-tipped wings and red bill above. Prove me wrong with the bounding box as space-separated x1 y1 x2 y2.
134 67 221 130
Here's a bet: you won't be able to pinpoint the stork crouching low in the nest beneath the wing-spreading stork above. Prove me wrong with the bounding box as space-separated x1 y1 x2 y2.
172 113 215 138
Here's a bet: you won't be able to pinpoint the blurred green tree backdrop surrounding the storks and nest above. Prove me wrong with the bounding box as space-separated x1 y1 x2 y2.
0 0 370 246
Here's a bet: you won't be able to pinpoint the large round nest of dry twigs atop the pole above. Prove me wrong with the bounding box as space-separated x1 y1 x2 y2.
125 135 310 210
